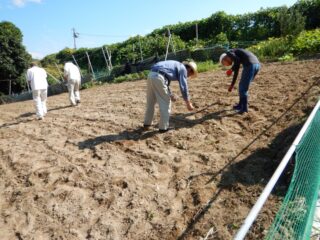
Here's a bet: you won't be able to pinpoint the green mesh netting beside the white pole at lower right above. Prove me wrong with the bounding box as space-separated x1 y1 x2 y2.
266 110 320 240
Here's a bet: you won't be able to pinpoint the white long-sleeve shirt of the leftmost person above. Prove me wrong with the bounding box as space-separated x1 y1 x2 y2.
27 66 48 90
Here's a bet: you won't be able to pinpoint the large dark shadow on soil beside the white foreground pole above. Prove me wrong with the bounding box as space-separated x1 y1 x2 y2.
177 121 302 240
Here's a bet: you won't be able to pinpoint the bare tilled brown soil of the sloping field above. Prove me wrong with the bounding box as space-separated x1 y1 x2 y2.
0 60 320 240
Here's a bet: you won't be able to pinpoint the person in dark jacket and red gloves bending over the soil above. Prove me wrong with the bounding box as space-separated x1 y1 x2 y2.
220 48 261 114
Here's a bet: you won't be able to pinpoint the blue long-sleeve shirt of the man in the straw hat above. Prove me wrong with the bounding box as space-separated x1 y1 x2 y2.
151 60 190 101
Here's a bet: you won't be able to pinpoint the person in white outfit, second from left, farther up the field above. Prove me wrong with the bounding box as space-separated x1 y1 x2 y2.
64 62 81 106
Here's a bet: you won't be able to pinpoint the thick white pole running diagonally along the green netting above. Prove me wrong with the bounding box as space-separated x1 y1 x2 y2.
234 100 320 240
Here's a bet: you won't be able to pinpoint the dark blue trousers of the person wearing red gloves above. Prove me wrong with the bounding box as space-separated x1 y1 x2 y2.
239 63 260 112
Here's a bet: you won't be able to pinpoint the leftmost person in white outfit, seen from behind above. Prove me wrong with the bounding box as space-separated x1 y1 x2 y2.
27 62 48 120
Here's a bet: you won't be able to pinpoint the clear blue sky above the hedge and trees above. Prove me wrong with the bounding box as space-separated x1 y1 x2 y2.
0 0 296 58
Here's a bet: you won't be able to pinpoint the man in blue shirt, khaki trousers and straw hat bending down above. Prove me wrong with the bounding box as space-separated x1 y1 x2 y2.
144 60 197 133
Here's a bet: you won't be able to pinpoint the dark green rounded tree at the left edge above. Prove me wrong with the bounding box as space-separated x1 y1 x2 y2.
0 22 31 94
